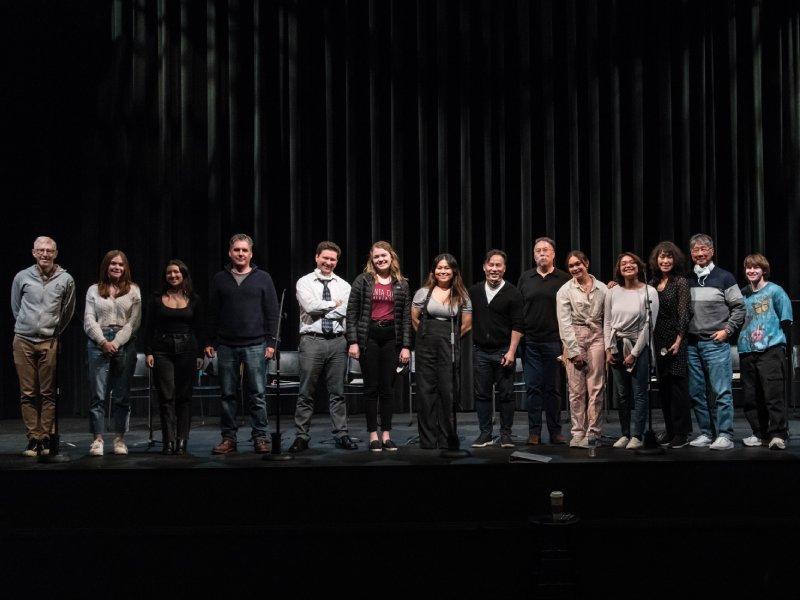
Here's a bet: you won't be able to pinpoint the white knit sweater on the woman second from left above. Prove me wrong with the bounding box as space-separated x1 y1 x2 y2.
83 283 142 346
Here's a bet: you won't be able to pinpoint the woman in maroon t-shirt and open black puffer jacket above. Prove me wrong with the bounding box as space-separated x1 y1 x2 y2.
346 242 411 452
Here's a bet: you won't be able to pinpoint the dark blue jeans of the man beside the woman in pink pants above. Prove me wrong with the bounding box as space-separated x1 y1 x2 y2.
522 342 563 437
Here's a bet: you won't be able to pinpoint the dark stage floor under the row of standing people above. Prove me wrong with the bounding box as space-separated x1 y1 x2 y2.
0 412 800 470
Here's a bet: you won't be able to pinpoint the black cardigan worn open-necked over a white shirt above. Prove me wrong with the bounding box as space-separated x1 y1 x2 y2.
469 281 523 350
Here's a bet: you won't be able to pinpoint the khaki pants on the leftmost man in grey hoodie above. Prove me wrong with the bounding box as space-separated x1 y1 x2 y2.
13 335 58 440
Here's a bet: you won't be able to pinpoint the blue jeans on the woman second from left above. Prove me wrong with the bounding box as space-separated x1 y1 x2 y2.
87 327 136 435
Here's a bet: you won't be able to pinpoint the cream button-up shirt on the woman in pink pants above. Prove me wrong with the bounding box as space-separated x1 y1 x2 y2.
556 275 608 358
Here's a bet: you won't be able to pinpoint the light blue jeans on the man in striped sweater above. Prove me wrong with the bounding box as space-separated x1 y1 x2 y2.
687 340 733 439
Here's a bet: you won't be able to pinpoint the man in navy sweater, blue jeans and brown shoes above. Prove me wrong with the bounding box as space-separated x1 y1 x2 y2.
205 233 280 454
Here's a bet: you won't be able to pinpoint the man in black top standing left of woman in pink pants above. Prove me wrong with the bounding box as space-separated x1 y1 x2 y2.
517 237 570 446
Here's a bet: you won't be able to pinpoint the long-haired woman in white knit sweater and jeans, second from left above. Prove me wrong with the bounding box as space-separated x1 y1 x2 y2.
83 250 142 456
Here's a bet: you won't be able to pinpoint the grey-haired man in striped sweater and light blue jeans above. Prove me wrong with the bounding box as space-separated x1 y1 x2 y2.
688 233 745 450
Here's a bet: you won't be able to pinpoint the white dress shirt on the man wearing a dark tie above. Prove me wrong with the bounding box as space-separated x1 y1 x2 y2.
295 269 350 335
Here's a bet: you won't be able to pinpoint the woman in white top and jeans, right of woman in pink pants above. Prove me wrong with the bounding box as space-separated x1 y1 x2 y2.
603 252 658 450
